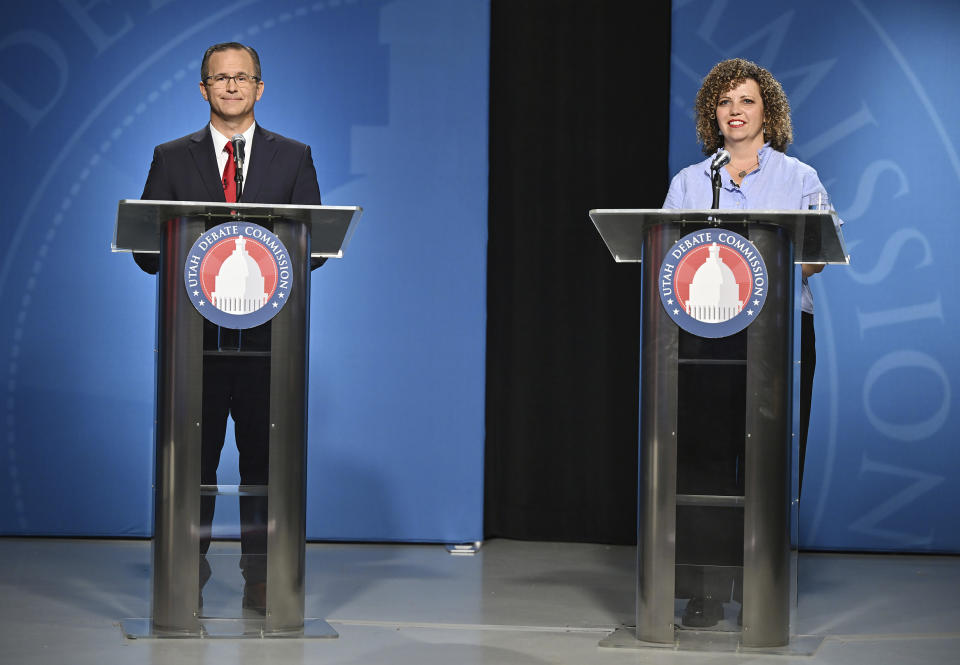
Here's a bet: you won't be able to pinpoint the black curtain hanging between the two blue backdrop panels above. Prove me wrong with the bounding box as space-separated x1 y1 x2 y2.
484 0 672 543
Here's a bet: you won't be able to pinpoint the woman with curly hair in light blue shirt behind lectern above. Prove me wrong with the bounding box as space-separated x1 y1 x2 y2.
663 58 824 627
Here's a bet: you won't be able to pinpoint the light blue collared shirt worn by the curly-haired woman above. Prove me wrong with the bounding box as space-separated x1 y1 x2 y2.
663 143 826 314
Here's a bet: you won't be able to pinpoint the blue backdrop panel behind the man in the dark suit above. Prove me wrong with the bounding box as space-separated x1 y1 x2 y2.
0 0 489 542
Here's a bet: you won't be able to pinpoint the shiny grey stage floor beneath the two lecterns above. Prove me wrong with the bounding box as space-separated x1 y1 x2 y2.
0 538 960 665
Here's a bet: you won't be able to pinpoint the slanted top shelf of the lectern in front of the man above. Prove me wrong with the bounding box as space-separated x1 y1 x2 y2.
111 199 363 258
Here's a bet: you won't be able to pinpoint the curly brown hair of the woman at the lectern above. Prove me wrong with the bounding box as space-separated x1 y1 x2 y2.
693 58 793 155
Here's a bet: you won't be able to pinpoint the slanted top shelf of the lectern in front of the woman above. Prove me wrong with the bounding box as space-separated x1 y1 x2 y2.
590 209 850 265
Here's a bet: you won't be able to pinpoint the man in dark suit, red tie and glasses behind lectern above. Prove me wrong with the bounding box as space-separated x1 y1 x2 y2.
134 42 320 611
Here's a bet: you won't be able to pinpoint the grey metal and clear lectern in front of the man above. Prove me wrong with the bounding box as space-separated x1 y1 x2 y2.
112 200 361 637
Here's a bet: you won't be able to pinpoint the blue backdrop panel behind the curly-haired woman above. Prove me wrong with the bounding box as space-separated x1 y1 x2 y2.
670 0 960 551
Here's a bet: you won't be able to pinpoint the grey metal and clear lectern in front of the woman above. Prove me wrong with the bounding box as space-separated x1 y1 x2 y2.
590 210 848 648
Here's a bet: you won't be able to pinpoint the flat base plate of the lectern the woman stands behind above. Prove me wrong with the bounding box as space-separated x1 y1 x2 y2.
599 626 823 656
